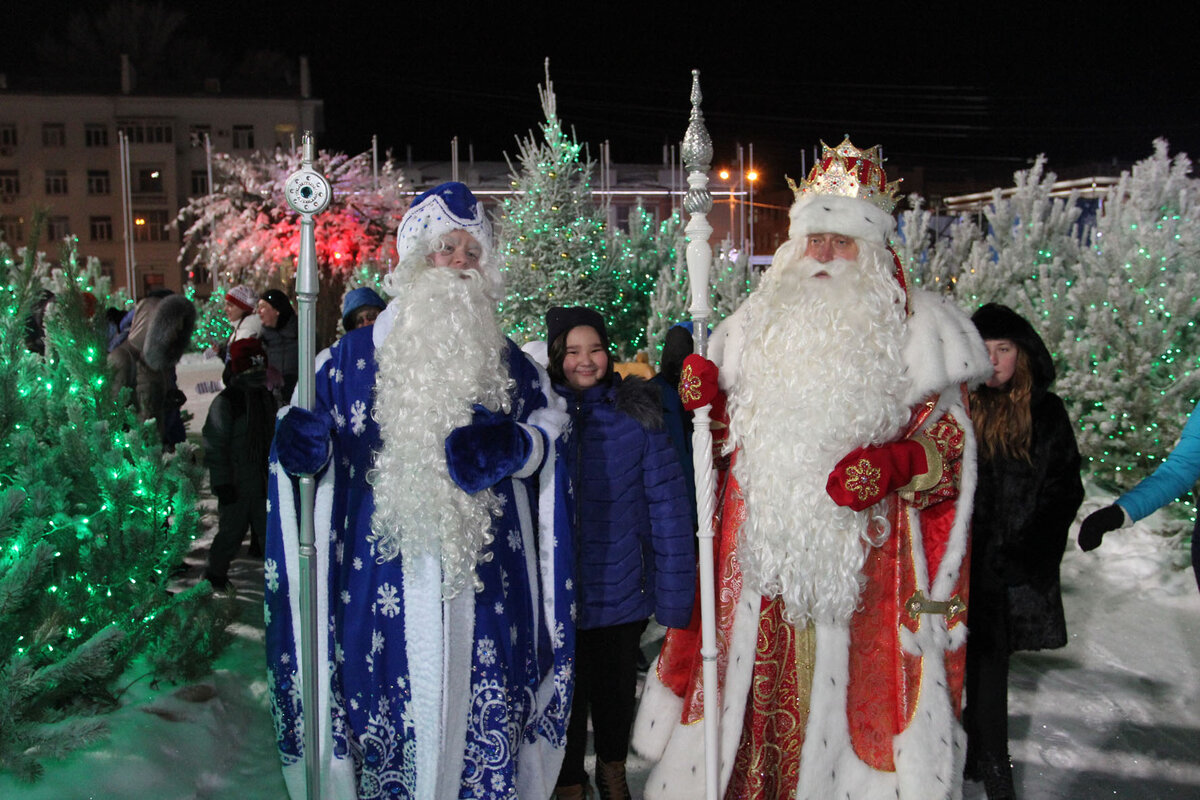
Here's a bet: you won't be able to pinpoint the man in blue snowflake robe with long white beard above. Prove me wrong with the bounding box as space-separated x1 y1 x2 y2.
264 182 575 800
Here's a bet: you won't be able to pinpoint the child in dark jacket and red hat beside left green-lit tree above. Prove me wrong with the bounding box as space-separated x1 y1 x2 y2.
203 338 277 589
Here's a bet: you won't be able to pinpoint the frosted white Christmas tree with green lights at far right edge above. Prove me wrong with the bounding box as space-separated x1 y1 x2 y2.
1057 140 1200 489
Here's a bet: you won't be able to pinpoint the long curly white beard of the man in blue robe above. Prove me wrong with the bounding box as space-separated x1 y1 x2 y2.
368 269 512 597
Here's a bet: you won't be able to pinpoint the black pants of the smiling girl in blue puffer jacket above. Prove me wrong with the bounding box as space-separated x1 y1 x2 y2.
558 619 647 786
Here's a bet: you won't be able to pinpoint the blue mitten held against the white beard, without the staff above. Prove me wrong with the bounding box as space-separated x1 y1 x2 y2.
446 409 540 494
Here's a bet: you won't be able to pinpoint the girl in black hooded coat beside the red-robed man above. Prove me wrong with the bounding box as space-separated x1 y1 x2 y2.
964 303 1084 800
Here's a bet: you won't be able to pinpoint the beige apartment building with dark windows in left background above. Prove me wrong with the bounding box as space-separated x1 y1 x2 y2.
0 82 324 296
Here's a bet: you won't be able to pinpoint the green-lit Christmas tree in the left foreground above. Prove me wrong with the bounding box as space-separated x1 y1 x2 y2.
0 221 230 780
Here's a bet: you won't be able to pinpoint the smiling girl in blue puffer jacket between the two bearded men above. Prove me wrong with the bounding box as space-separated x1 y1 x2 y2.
546 308 696 798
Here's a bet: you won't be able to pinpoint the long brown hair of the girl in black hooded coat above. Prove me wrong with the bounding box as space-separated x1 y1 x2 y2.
971 344 1033 462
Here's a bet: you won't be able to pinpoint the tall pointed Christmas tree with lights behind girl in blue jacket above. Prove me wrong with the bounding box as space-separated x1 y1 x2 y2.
497 60 631 350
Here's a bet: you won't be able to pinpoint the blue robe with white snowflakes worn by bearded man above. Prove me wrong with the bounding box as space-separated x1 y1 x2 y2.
265 327 575 800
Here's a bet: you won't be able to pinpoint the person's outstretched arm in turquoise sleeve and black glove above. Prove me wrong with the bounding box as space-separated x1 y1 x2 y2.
1079 414 1200 588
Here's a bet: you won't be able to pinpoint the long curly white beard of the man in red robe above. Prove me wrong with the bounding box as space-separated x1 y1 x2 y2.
730 242 908 625
